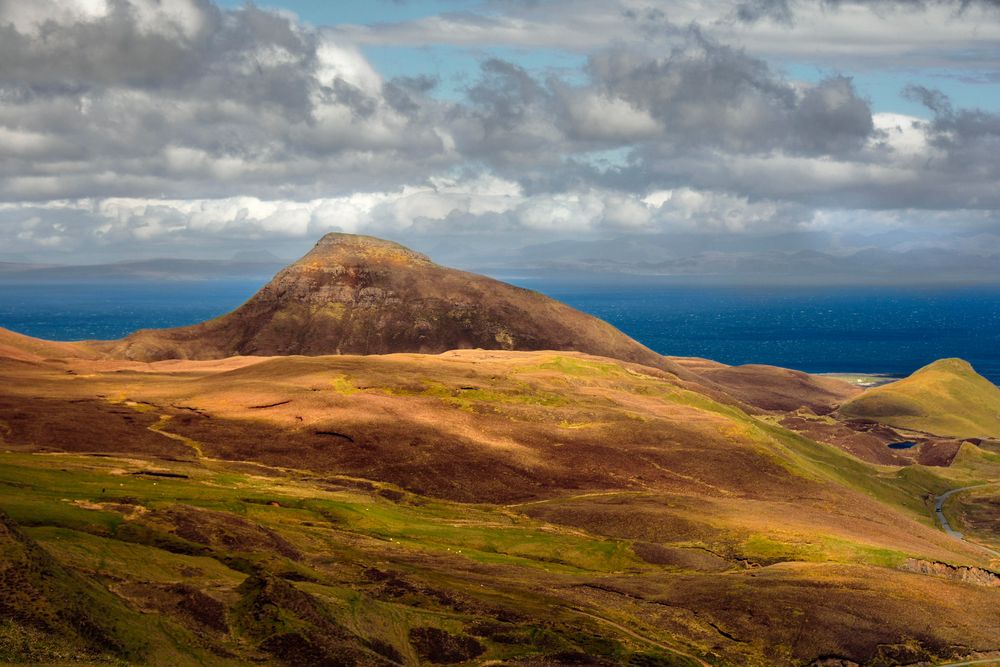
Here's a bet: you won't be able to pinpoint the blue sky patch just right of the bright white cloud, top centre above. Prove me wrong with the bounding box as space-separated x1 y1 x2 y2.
362 44 587 100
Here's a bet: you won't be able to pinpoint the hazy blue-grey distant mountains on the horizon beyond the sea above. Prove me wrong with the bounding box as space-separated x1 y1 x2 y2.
0 233 1000 285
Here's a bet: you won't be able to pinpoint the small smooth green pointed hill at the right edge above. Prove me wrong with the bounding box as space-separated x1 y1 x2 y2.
840 359 1000 438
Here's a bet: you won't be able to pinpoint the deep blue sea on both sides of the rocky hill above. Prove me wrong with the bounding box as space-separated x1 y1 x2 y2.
0 279 1000 384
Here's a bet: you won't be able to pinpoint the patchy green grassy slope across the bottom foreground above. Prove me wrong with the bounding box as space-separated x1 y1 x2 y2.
0 452 1000 667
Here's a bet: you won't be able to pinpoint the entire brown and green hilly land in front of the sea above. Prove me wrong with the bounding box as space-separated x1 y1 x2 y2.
0 234 1000 667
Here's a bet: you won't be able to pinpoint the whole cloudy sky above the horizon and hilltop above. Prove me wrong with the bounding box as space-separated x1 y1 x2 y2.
0 0 1000 274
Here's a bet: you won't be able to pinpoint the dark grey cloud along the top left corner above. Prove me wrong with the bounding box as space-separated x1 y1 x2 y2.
0 0 324 118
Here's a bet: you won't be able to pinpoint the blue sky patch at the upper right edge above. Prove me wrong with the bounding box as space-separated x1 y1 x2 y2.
784 63 1000 118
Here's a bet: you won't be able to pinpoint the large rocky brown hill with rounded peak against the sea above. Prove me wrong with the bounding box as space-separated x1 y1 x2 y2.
101 234 673 369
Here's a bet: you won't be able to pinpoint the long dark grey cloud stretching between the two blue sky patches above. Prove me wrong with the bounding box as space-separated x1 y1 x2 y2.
449 32 874 179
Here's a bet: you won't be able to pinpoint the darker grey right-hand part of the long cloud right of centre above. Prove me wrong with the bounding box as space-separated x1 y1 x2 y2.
589 39 873 154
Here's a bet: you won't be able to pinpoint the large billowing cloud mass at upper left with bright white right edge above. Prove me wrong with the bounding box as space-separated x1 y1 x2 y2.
0 0 449 199
